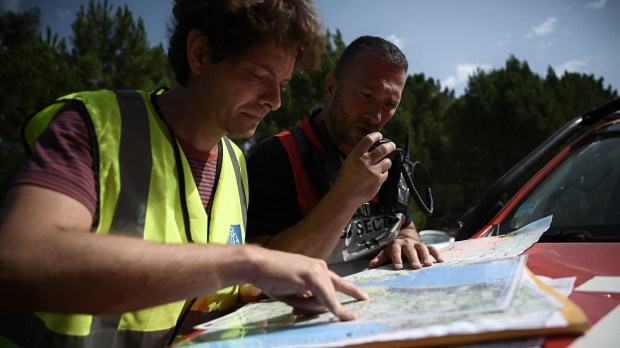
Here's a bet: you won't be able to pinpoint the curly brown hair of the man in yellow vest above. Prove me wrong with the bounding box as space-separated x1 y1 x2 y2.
168 0 325 85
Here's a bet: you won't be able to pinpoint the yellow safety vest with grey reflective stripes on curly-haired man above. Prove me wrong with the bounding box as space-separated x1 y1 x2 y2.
0 90 248 347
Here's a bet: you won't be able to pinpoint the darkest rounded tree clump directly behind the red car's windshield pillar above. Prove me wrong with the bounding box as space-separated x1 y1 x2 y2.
432 57 618 231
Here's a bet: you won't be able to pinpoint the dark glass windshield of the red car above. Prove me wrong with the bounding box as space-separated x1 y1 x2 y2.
498 123 620 242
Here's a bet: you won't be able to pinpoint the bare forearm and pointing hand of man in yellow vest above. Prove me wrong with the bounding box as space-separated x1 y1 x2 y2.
0 220 368 320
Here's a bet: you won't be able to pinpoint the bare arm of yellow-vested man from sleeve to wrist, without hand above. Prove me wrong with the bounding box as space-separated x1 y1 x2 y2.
0 186 254 313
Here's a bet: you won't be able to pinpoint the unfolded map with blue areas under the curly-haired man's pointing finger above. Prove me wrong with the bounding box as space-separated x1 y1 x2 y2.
175 216 566 348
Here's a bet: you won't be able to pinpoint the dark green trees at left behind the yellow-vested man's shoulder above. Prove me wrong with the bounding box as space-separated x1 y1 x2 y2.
0 0 172 198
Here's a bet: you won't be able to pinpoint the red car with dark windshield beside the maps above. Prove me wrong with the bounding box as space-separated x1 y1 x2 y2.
456 99 620 347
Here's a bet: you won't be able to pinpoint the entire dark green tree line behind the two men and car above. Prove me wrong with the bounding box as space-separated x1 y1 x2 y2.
0 0 618 230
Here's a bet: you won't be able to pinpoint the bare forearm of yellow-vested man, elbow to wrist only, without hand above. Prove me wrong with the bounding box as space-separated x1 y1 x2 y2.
0 228 251 313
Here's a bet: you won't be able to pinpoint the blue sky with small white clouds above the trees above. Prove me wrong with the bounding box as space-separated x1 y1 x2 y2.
0 0 620 95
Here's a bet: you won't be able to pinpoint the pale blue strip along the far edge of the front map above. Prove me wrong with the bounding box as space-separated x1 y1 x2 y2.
354 262 517 288
